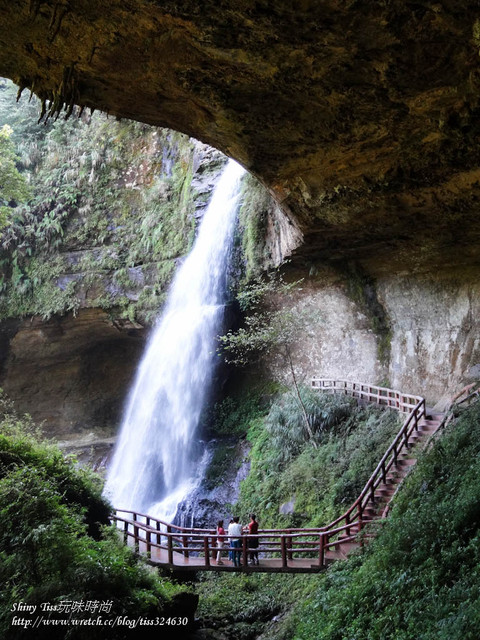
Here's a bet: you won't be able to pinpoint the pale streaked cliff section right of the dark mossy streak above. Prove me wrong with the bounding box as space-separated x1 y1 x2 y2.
379 271 480 403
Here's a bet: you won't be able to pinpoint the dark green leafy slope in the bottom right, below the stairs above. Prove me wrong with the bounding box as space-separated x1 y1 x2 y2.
295 403 480 640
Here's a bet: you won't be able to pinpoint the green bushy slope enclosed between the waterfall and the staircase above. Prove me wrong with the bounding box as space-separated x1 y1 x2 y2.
234 388 399 528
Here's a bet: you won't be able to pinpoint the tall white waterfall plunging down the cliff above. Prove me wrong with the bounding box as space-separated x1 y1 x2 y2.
105 160 244 521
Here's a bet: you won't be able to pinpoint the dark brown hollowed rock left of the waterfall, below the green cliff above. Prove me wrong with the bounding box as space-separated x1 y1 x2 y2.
0 309 145 439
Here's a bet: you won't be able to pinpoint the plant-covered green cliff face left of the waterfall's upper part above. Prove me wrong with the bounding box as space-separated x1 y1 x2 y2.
0 81 204 320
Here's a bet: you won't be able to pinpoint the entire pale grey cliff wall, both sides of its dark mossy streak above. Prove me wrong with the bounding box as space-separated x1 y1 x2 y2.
268 270 480 406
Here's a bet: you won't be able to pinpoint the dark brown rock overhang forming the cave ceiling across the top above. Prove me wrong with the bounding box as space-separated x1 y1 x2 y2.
0 0 480 274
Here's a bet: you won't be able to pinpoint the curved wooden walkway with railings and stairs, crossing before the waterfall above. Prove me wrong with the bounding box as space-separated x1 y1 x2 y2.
112 378 454 573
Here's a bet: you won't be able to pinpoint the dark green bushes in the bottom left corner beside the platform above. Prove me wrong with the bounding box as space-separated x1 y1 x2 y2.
0 395 191 640
